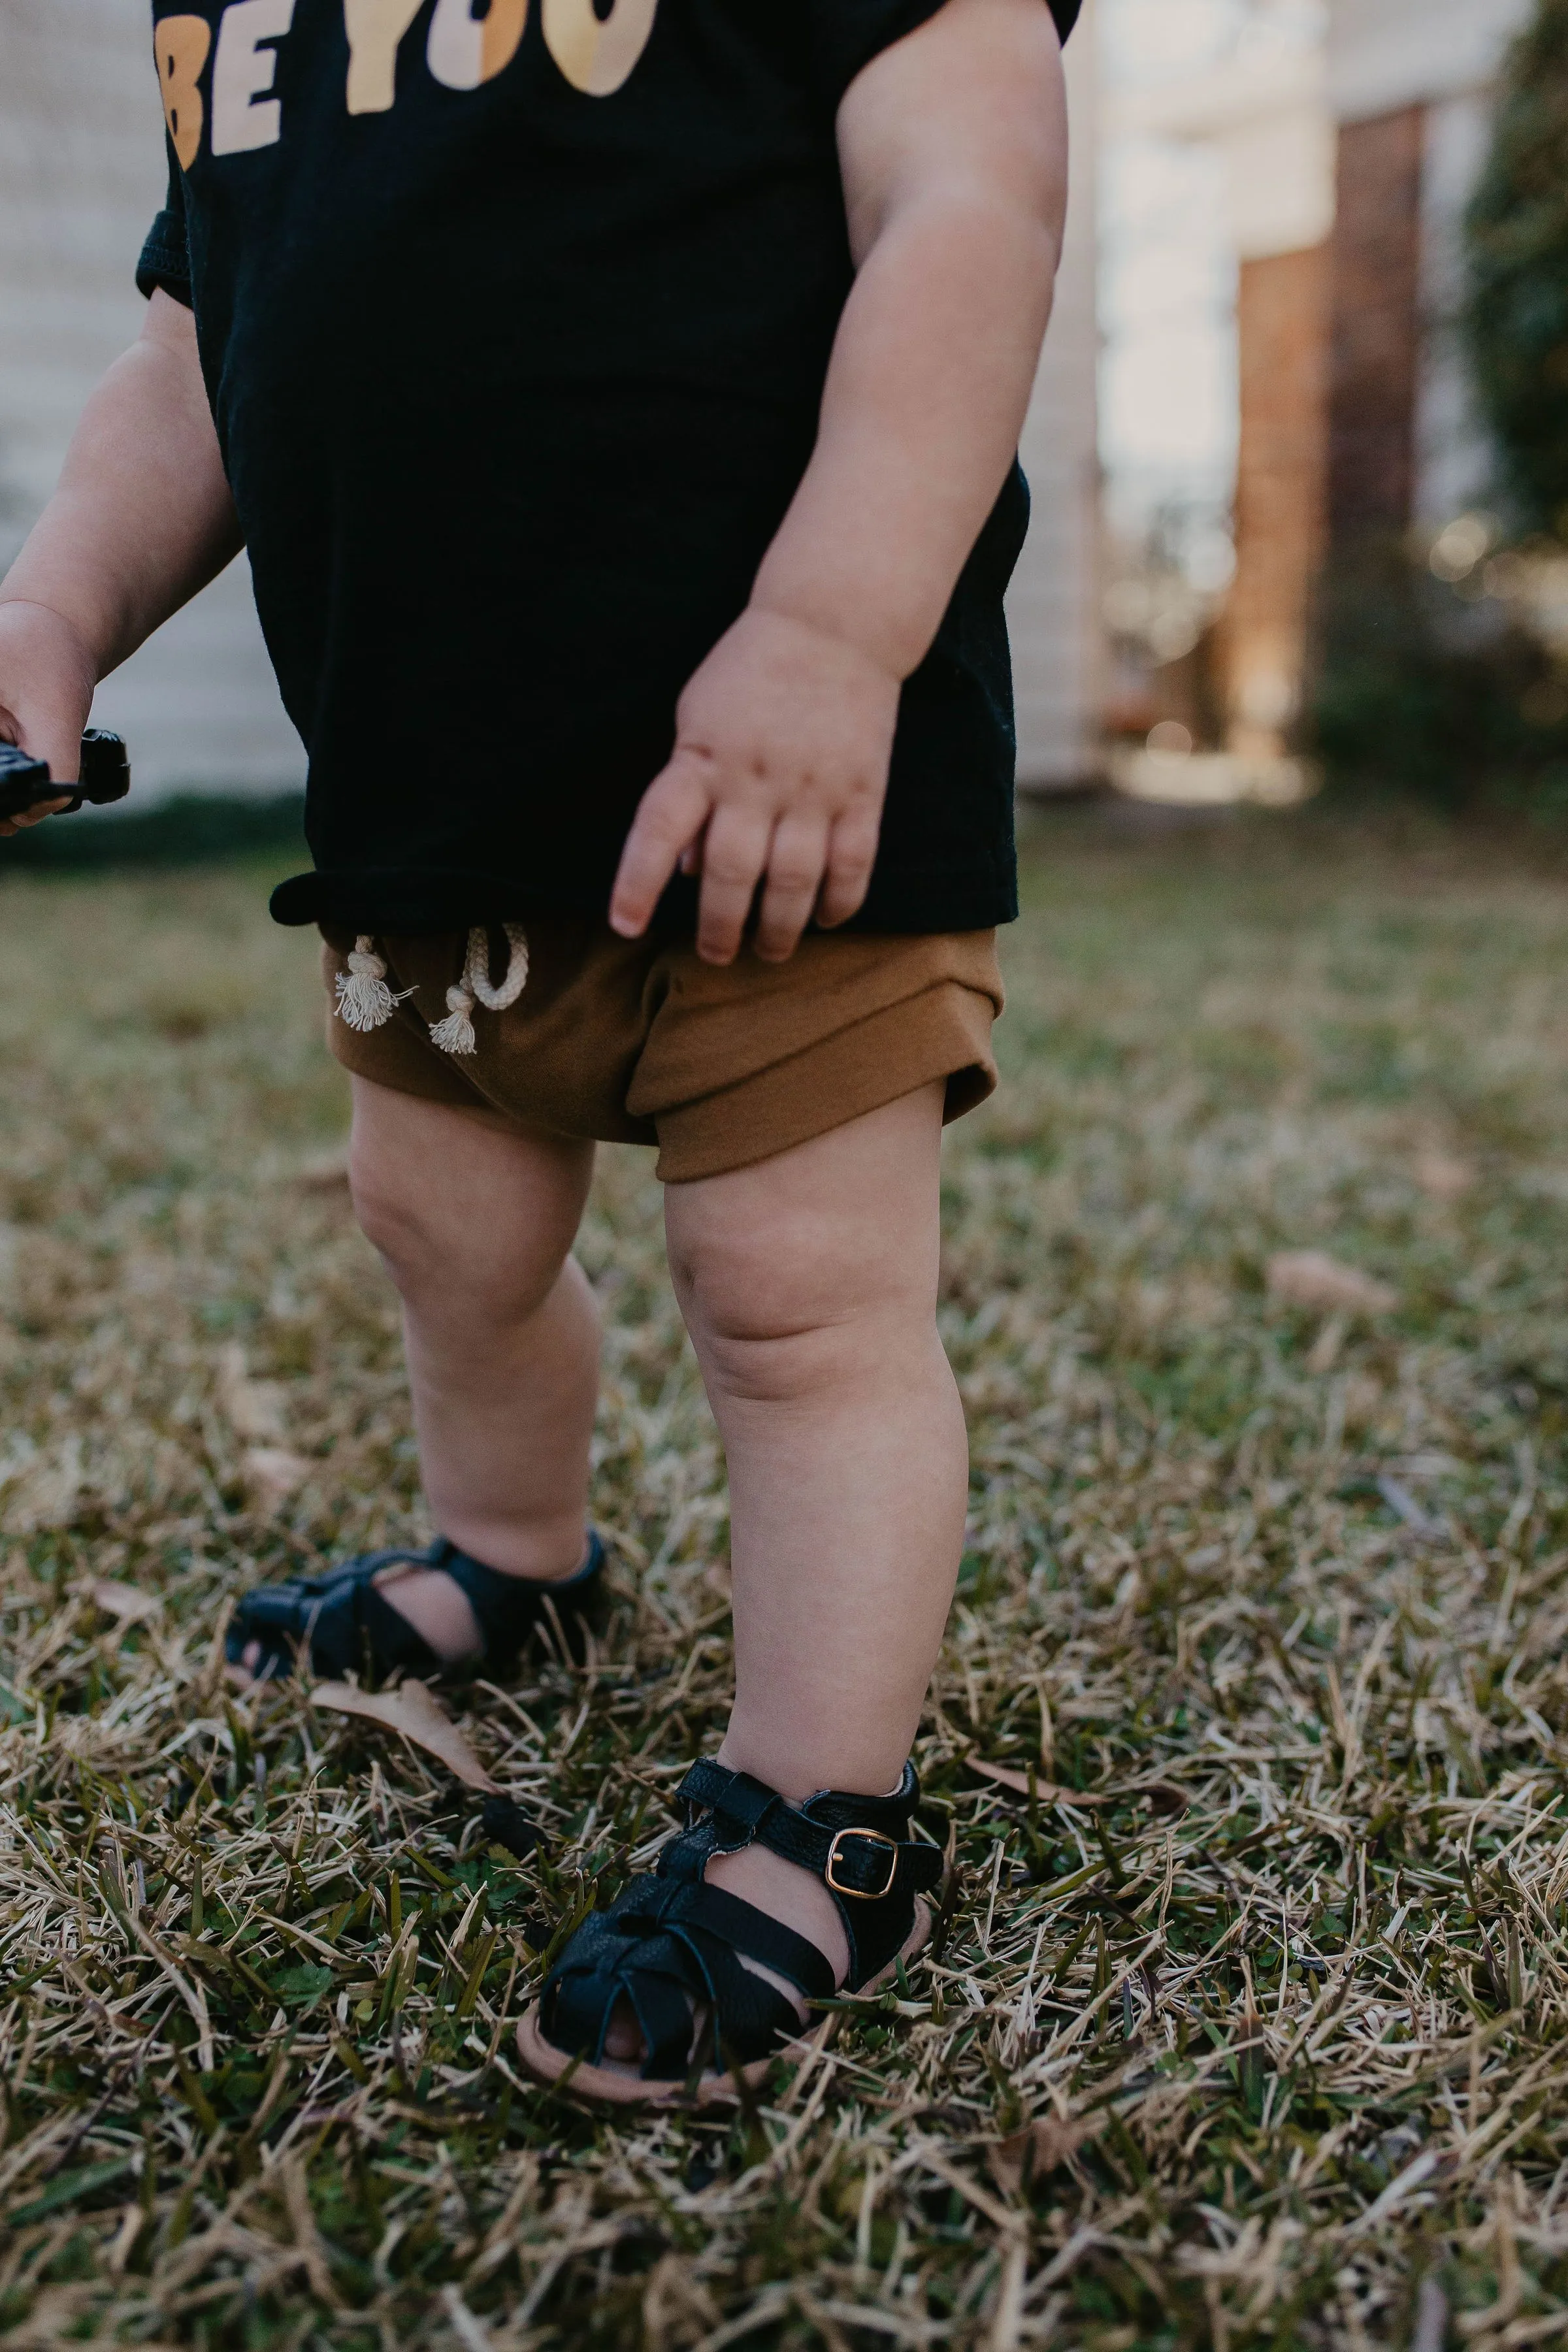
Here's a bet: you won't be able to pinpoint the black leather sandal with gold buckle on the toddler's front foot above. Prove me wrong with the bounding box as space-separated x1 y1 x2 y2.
517 1761 943 2108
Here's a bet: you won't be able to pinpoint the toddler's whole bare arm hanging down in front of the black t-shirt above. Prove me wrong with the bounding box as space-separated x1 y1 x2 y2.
612 0 1068 964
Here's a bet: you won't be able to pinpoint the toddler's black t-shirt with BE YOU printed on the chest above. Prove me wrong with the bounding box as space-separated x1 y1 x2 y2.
139 0 1079 932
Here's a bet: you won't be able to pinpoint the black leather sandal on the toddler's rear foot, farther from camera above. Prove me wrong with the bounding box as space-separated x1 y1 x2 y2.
225 1533 604 1682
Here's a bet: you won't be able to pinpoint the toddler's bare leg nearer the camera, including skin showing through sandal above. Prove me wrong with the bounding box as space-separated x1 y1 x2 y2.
665 1085 968 1978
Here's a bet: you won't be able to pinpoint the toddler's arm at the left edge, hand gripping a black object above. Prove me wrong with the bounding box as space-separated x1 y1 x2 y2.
0 294 240 835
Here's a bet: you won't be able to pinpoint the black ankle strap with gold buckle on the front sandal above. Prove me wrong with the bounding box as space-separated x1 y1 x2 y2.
672 1757 943 1903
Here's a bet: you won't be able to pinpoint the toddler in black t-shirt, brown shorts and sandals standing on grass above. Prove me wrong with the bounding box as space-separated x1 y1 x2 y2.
0 0 1077 2105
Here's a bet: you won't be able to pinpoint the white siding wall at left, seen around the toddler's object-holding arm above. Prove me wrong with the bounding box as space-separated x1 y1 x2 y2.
0 0 303 795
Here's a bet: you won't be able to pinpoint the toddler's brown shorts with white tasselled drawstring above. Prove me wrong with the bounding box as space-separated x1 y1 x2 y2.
322 917 1002 1183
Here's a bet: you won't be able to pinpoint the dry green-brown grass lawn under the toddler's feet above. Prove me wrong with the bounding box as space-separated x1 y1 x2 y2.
0 814 1568 2352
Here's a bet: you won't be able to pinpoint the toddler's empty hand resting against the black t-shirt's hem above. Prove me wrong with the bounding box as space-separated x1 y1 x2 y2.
609 607 900 964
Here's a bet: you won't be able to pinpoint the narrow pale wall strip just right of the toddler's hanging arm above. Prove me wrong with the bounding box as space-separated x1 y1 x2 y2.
1009 0 1105 791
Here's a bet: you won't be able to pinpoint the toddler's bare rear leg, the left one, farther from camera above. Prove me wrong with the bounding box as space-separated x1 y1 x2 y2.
244 1077 600 1665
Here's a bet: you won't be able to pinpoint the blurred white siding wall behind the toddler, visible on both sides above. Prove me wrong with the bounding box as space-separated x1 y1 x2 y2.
0 0 1100 792
